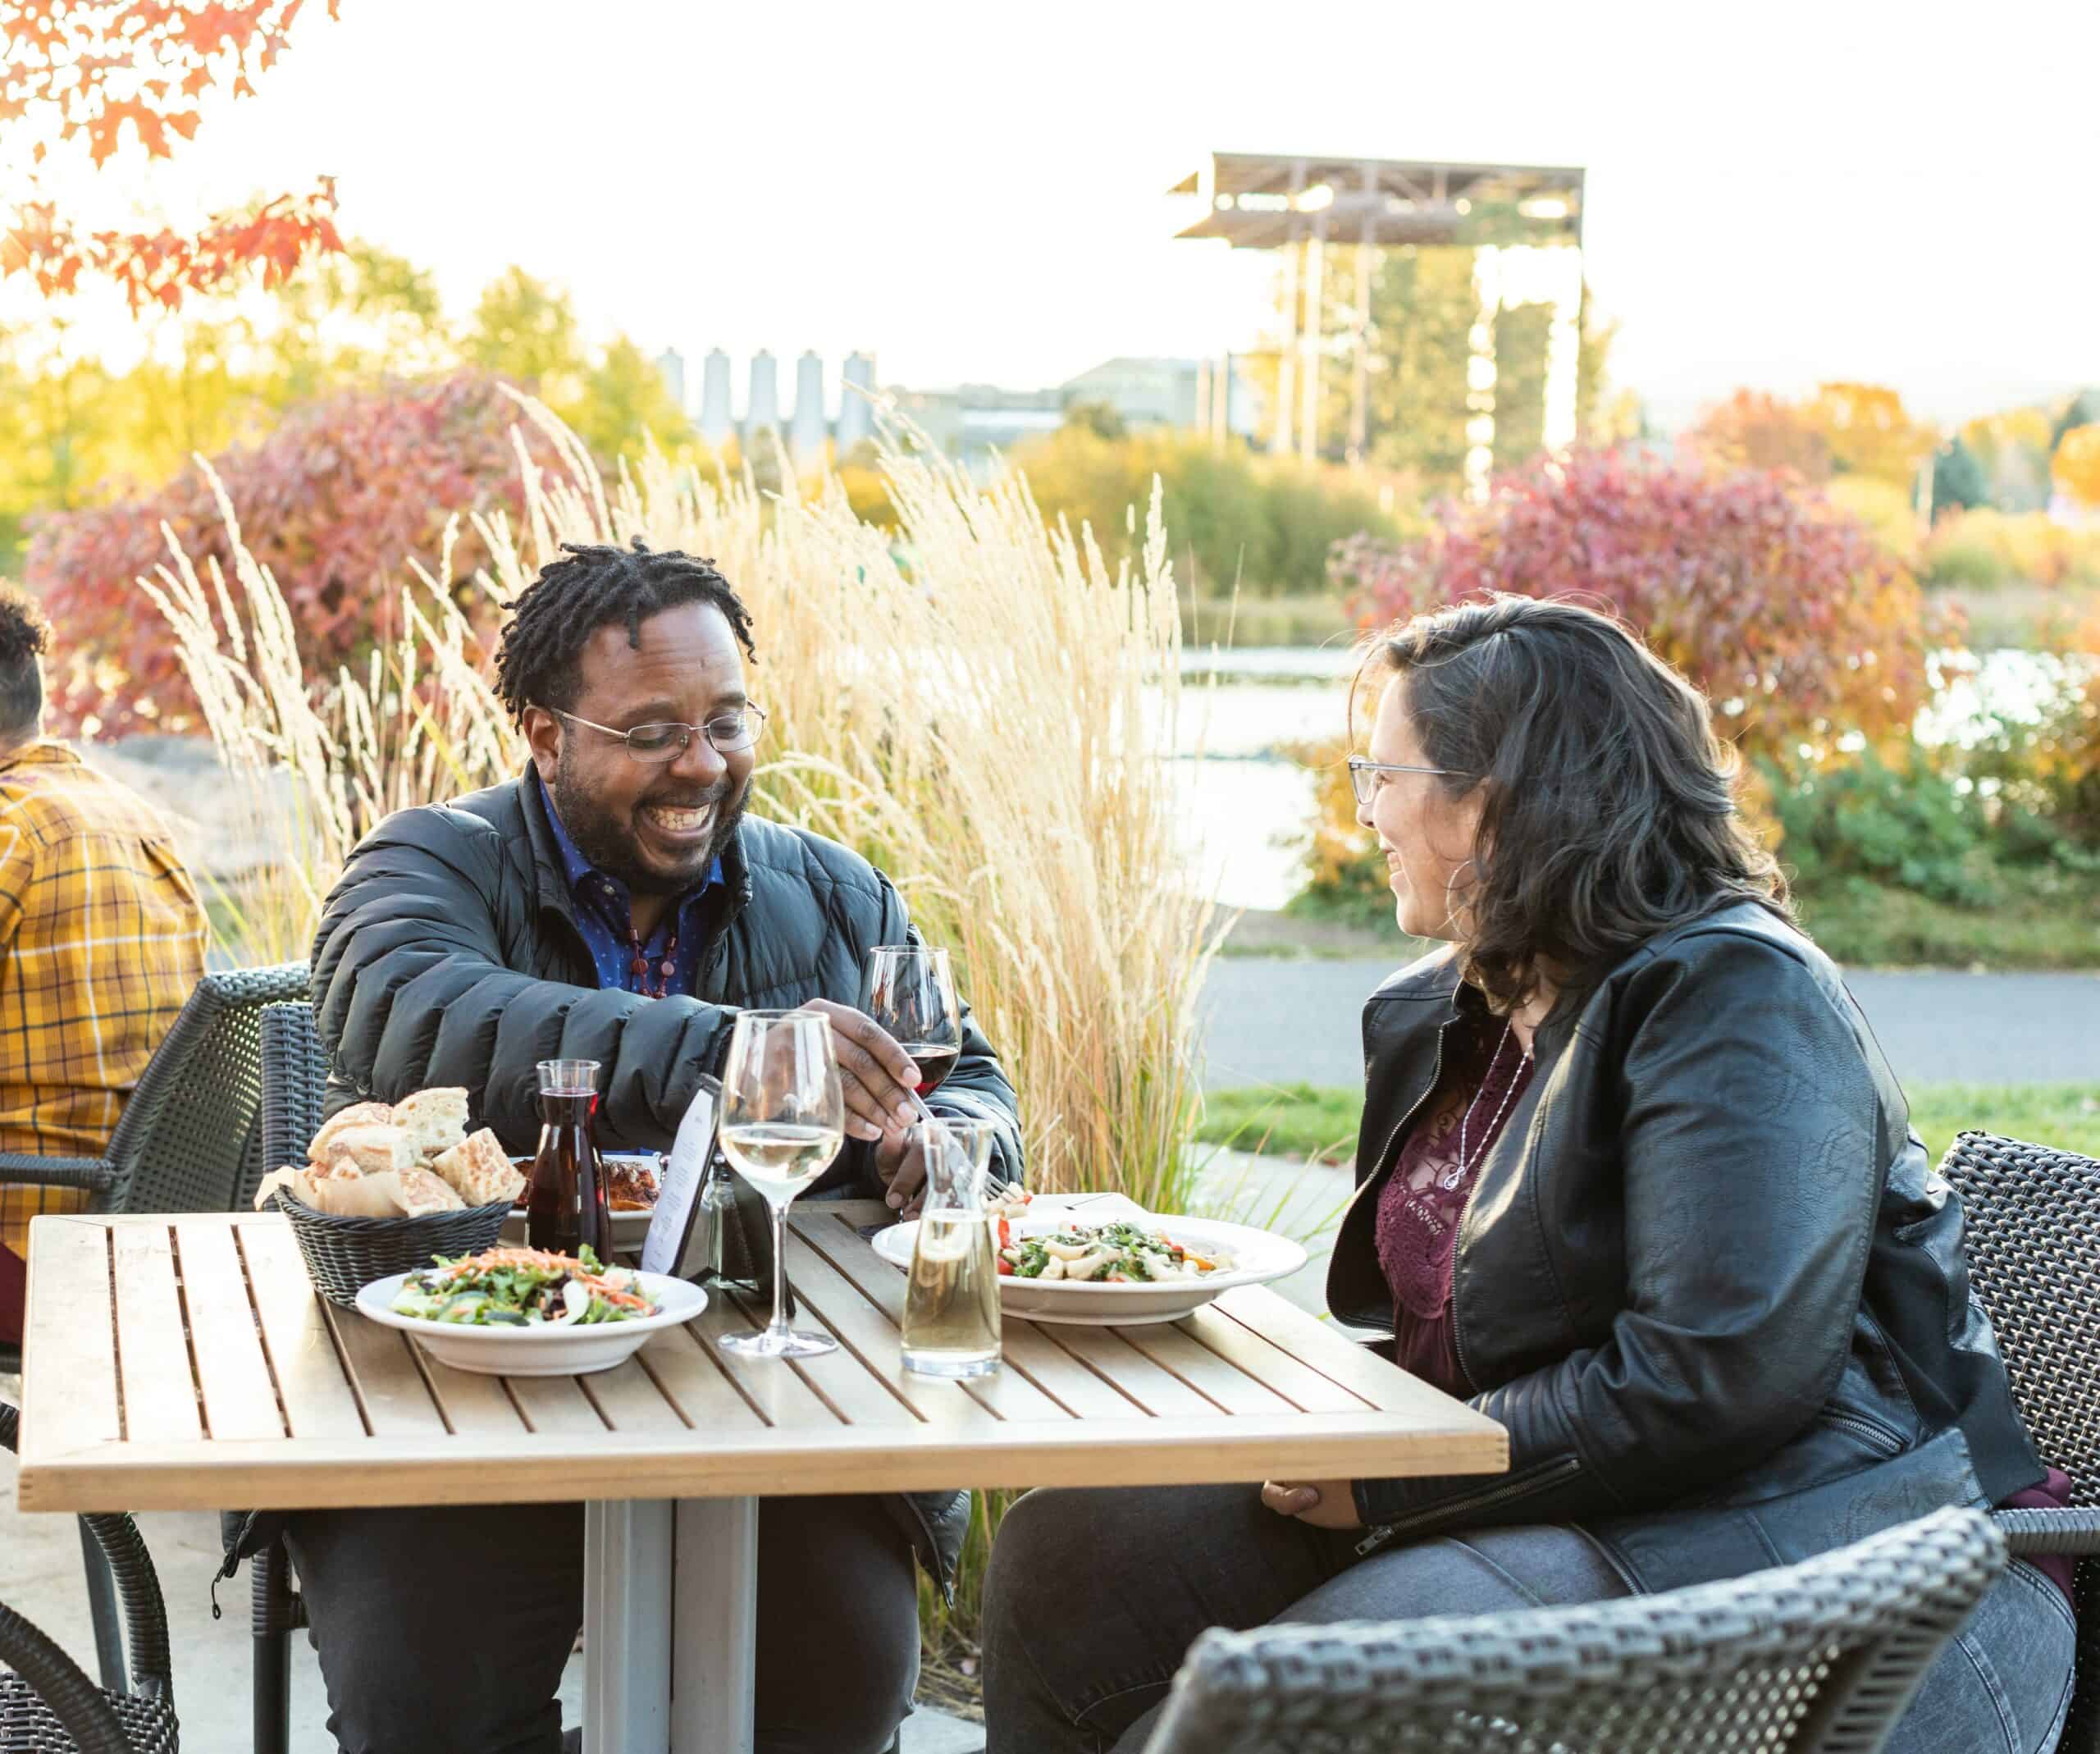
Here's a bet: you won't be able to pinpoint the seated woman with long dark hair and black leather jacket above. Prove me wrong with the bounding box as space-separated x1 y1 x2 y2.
985 596 2073 1754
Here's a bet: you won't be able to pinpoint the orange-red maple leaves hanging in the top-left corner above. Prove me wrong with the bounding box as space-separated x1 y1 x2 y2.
0 0 342 311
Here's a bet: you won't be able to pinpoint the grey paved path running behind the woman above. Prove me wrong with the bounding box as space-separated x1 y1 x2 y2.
1203 956 2100 1090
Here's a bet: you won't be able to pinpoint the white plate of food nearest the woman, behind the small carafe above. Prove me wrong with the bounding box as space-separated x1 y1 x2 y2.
874 1193 1306 1327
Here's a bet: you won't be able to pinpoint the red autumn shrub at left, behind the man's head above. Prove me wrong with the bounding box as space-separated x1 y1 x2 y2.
23 372 552 735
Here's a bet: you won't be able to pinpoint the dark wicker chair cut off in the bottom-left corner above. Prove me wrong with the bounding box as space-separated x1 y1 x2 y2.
0 1403 176 1754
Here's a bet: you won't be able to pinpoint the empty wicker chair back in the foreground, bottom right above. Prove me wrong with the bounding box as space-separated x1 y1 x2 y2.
1147 1510 2006 1754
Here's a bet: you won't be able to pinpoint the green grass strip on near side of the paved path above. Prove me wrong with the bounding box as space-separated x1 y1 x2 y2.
1197 1084 2100 1162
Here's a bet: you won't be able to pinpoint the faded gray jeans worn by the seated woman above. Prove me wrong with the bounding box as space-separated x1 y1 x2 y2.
985 1487 2075 1754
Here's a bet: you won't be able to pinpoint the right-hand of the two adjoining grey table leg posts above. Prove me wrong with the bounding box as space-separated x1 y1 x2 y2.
668 1498 758 1754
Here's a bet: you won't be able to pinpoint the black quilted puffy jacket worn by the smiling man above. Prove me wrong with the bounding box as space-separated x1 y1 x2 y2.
313 775 1023 1582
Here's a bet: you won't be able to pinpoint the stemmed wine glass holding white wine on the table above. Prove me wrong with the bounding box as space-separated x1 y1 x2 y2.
719 1011 847 1359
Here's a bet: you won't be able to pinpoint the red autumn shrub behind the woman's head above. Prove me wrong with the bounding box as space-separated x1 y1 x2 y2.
1329 452 1928 767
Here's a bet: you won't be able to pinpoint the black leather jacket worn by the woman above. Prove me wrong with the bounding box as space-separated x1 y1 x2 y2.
1327 903 2041 1588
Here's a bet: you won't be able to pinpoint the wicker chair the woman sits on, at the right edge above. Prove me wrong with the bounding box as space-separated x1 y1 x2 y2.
1940 1132 2100 1754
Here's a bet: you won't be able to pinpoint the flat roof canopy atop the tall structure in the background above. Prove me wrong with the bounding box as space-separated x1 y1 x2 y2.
1167 151 1583 250
